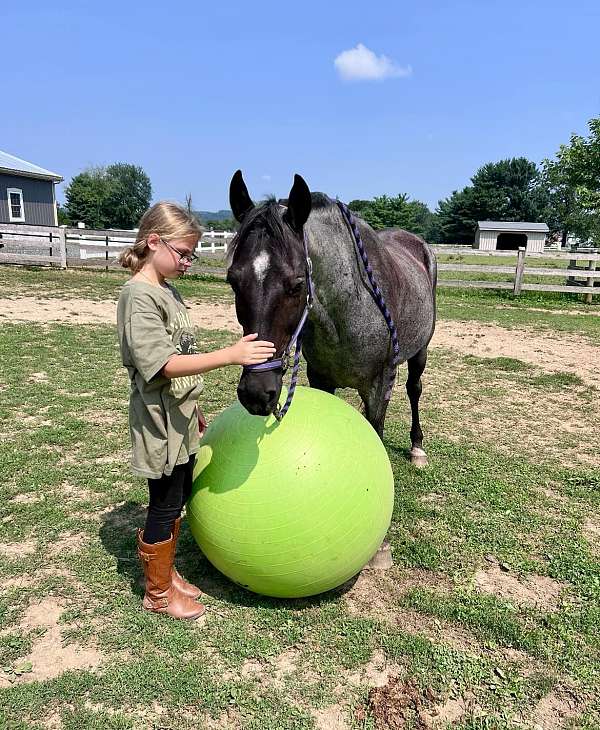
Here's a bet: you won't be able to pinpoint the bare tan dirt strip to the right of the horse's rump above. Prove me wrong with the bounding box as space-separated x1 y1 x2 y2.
431 320 600 386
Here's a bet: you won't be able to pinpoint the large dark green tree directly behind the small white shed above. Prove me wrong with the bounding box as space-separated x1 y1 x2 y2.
437 157 547 243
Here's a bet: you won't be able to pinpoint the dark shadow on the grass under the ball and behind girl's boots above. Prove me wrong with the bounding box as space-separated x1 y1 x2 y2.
99 502 358 610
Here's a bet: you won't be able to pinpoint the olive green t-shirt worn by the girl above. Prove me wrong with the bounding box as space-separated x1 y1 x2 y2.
117 279 203 479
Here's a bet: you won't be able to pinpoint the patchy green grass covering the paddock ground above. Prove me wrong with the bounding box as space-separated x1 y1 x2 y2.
0 268 600 730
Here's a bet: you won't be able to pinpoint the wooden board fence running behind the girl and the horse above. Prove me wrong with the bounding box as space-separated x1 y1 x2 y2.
0 224 600 303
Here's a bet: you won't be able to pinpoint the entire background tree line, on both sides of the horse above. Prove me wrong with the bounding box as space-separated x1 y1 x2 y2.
59 117 600 245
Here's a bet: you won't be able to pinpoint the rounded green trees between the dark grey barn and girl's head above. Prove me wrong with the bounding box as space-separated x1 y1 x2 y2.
65 162 152 229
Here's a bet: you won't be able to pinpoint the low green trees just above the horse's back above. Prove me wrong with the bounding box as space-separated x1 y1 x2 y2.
348 193 432 236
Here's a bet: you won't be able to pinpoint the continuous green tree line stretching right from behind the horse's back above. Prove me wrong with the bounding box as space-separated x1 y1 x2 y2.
350 118 600 245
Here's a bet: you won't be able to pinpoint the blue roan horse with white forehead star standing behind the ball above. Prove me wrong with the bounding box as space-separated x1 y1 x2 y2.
227 170 436 466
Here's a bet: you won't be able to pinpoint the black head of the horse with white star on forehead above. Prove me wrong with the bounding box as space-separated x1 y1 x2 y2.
227 170 311 416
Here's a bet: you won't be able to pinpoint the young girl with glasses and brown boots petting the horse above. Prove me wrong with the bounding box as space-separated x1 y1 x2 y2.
117 202 275 619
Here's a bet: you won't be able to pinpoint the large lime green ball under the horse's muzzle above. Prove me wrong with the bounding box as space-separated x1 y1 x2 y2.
187 388 394 598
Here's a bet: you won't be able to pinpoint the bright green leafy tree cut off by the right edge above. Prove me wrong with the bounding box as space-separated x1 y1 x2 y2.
542 117 600 245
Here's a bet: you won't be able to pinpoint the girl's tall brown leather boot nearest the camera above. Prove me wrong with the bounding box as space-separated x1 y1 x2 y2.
137 530 205 619
